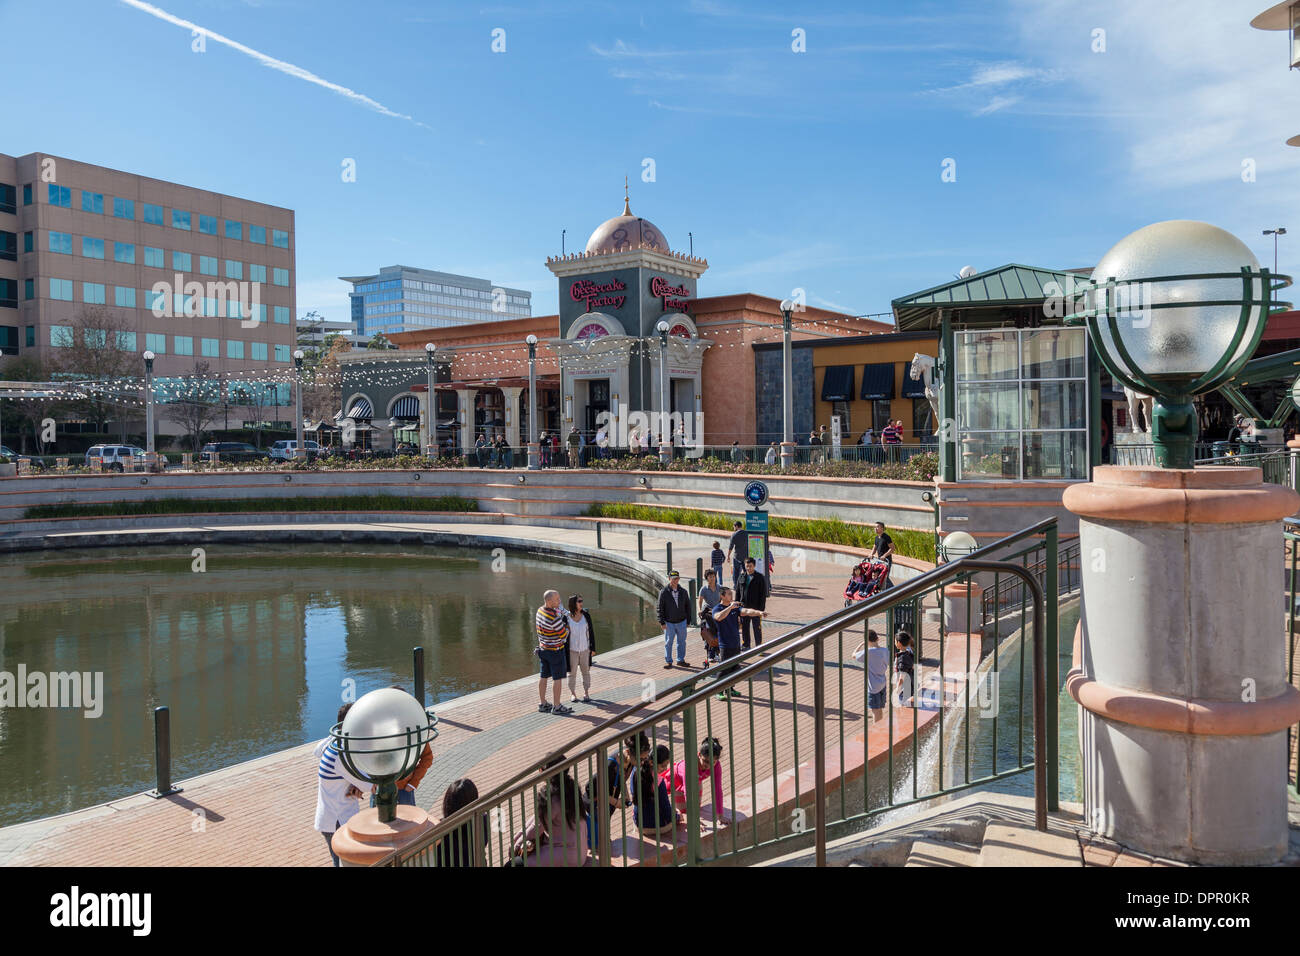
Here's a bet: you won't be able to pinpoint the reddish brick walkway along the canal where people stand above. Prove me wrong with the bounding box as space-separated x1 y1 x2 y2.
0 524 978 866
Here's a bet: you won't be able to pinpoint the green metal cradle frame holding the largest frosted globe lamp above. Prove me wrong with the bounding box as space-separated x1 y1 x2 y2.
1063 265 1291 468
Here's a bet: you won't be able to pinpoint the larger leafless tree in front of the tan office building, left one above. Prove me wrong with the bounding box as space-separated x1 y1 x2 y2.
49 306 144 441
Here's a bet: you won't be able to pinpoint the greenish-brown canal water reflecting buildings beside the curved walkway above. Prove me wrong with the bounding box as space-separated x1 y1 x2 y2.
0 544 657 826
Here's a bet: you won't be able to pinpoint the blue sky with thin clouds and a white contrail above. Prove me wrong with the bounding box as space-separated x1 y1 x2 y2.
0 0 1300 319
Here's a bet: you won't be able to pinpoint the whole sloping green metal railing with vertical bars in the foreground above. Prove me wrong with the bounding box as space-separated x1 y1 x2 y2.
384 519 1078 866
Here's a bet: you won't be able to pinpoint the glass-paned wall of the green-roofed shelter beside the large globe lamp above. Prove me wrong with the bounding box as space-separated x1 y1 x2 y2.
956 329 1088 480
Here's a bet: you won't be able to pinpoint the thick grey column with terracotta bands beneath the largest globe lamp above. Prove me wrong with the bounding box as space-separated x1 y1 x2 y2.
1065 466 1300 865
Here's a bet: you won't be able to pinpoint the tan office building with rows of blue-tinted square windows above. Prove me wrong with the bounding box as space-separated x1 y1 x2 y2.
0 153 296 431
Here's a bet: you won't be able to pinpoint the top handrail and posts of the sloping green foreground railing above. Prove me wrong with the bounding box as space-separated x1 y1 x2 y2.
377 518 1057 866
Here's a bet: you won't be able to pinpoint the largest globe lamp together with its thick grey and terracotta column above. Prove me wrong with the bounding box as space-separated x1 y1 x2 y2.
1047 220 1300 865
